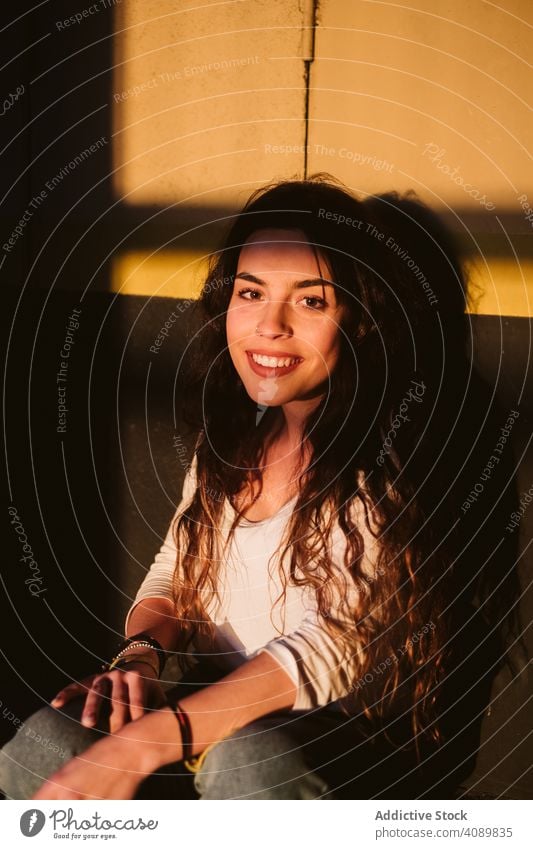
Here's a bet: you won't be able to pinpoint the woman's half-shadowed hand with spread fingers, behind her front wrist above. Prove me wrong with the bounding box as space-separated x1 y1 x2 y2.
51 663 166 734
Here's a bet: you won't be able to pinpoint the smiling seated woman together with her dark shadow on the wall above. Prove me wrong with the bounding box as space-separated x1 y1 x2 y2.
0 175 512 799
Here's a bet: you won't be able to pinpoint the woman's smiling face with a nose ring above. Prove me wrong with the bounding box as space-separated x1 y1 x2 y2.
226 229 342 406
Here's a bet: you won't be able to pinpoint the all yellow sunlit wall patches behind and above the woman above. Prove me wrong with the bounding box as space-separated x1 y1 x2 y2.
112 0 533 316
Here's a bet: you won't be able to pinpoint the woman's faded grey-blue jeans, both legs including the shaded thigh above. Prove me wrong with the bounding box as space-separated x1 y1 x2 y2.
0 664 426 799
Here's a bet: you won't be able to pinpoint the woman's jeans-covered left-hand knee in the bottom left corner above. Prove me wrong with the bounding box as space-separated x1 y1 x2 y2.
0 700 102 799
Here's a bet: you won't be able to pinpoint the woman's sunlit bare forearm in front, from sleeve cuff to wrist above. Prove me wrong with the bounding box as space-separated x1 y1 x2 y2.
119 653 296 773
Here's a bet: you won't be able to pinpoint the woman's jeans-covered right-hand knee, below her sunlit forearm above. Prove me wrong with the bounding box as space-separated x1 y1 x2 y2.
195 719 328 799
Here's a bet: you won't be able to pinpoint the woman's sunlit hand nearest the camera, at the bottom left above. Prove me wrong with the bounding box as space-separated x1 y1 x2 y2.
32 735 150 799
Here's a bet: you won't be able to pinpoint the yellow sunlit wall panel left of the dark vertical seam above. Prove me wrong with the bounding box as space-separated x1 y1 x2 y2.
113 0 305 206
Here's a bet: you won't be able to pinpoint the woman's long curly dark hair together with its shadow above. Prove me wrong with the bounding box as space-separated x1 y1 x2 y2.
169 174 513 756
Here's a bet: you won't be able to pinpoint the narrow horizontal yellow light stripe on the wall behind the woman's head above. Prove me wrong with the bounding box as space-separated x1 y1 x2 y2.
111 250 533 317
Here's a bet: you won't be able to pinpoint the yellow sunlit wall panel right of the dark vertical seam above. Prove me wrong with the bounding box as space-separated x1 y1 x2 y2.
309 0 533 208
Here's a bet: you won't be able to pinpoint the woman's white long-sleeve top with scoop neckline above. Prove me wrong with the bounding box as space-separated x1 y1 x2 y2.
126 462 377 710
